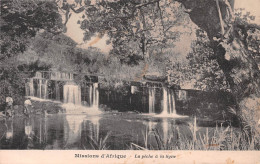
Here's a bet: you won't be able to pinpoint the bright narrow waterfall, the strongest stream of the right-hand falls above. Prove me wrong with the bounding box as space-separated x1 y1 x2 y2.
161 87 176 115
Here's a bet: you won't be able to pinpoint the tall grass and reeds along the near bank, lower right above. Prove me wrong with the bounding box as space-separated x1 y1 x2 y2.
130 118 260 150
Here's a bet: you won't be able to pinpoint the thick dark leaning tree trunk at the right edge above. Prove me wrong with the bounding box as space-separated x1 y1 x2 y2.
176 0 260 128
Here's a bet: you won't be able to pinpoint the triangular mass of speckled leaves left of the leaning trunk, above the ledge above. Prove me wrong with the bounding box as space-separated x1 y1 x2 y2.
168 29 229 91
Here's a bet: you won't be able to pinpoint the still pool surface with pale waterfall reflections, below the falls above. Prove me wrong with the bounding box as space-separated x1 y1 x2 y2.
0 113 195 150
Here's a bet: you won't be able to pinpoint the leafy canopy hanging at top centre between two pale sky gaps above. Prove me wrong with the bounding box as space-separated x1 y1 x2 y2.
71 0 187 60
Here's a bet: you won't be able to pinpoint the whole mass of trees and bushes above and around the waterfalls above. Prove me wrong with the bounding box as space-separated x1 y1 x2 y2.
0 0 260 146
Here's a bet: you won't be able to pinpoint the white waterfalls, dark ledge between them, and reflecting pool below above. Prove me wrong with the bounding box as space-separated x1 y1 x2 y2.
0 72 231 150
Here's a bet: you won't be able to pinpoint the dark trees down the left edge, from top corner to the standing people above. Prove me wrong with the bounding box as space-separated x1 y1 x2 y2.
0 0 62 104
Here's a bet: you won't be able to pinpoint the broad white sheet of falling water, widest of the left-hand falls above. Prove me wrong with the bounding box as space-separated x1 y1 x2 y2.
63 84 81 105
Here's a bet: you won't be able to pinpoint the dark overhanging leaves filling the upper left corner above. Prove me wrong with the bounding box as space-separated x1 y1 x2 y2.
0 0 62 60
